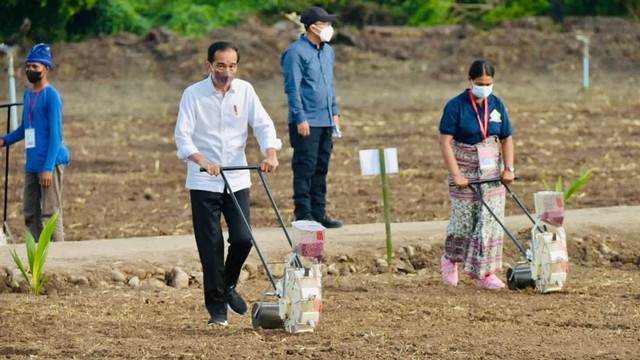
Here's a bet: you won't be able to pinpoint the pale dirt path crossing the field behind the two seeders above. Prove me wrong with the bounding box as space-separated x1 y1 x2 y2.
0 206 640 272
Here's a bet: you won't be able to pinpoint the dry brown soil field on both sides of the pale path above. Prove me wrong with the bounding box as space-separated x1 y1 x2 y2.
0 19 640 359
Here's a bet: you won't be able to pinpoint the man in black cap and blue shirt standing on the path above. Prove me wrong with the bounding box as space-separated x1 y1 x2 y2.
280 6 342 228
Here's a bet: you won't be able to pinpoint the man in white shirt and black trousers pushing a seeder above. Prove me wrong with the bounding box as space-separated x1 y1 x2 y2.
175 41 282 326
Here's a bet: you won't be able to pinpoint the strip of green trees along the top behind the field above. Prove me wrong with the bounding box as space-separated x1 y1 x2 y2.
0 0 640 43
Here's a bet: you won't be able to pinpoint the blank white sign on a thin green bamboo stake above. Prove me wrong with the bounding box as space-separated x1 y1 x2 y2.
360 148 398 285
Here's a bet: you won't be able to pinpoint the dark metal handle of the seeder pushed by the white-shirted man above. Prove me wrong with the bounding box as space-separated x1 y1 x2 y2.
200 165 302 290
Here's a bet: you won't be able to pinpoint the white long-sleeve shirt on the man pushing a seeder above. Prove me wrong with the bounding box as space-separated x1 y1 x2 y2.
174 76 282 193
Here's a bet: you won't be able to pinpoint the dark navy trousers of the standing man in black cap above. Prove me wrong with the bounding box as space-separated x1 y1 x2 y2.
289 123 333 219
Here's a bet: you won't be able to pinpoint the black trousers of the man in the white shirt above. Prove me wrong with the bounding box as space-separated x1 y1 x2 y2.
190 189 251 315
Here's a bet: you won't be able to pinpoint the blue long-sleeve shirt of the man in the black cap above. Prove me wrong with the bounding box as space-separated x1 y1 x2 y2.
280 35 338 127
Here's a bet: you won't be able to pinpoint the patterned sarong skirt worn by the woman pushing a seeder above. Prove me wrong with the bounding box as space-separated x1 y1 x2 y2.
444 139 505 279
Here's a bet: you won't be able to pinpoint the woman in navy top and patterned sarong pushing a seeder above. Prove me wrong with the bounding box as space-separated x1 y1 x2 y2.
440 60 514 290
